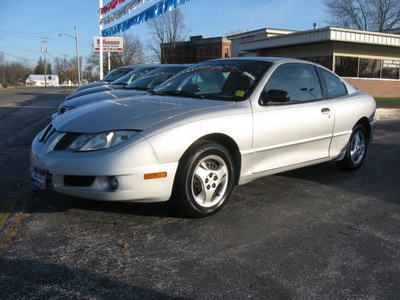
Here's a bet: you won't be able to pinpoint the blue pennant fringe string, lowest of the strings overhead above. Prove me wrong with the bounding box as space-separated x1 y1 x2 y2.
102 0 190 37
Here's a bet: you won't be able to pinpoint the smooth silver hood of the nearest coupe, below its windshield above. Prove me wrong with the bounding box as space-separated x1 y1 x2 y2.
53 95 235 133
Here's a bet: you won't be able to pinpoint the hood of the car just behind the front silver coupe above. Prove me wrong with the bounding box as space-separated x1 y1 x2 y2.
62 90 147 108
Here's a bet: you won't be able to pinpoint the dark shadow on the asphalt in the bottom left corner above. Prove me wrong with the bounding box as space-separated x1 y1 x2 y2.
0 258 184 299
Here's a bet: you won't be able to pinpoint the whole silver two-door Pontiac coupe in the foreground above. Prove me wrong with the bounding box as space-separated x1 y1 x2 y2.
31 57 376 217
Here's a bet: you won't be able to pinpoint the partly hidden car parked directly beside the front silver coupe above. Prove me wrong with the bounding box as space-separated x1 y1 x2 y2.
52 64 192 120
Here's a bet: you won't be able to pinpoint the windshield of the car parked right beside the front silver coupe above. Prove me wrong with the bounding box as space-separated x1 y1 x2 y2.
125 67 186 90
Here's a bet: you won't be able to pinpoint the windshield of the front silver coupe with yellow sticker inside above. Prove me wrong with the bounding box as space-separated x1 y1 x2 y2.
154 60 271 101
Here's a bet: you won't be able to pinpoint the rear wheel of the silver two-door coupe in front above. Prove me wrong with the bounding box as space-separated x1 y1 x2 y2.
338 124 368 171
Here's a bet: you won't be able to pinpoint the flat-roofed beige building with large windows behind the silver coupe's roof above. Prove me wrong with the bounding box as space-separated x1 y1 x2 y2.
227 27 400 80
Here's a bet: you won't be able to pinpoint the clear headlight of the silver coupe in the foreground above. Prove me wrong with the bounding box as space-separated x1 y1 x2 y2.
66 130 136 151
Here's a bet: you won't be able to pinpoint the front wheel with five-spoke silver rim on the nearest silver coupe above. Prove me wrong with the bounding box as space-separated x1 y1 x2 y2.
173 141 235 217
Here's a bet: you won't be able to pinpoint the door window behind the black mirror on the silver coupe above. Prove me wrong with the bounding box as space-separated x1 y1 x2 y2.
264 64 322 102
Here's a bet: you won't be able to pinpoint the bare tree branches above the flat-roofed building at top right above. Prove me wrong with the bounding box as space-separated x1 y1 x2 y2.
323 0 400 31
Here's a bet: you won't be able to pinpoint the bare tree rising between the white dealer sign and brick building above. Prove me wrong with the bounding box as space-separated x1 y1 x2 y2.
146 8 188 64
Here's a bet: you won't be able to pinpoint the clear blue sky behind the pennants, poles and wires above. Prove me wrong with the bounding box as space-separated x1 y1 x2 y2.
0 0 329 67
